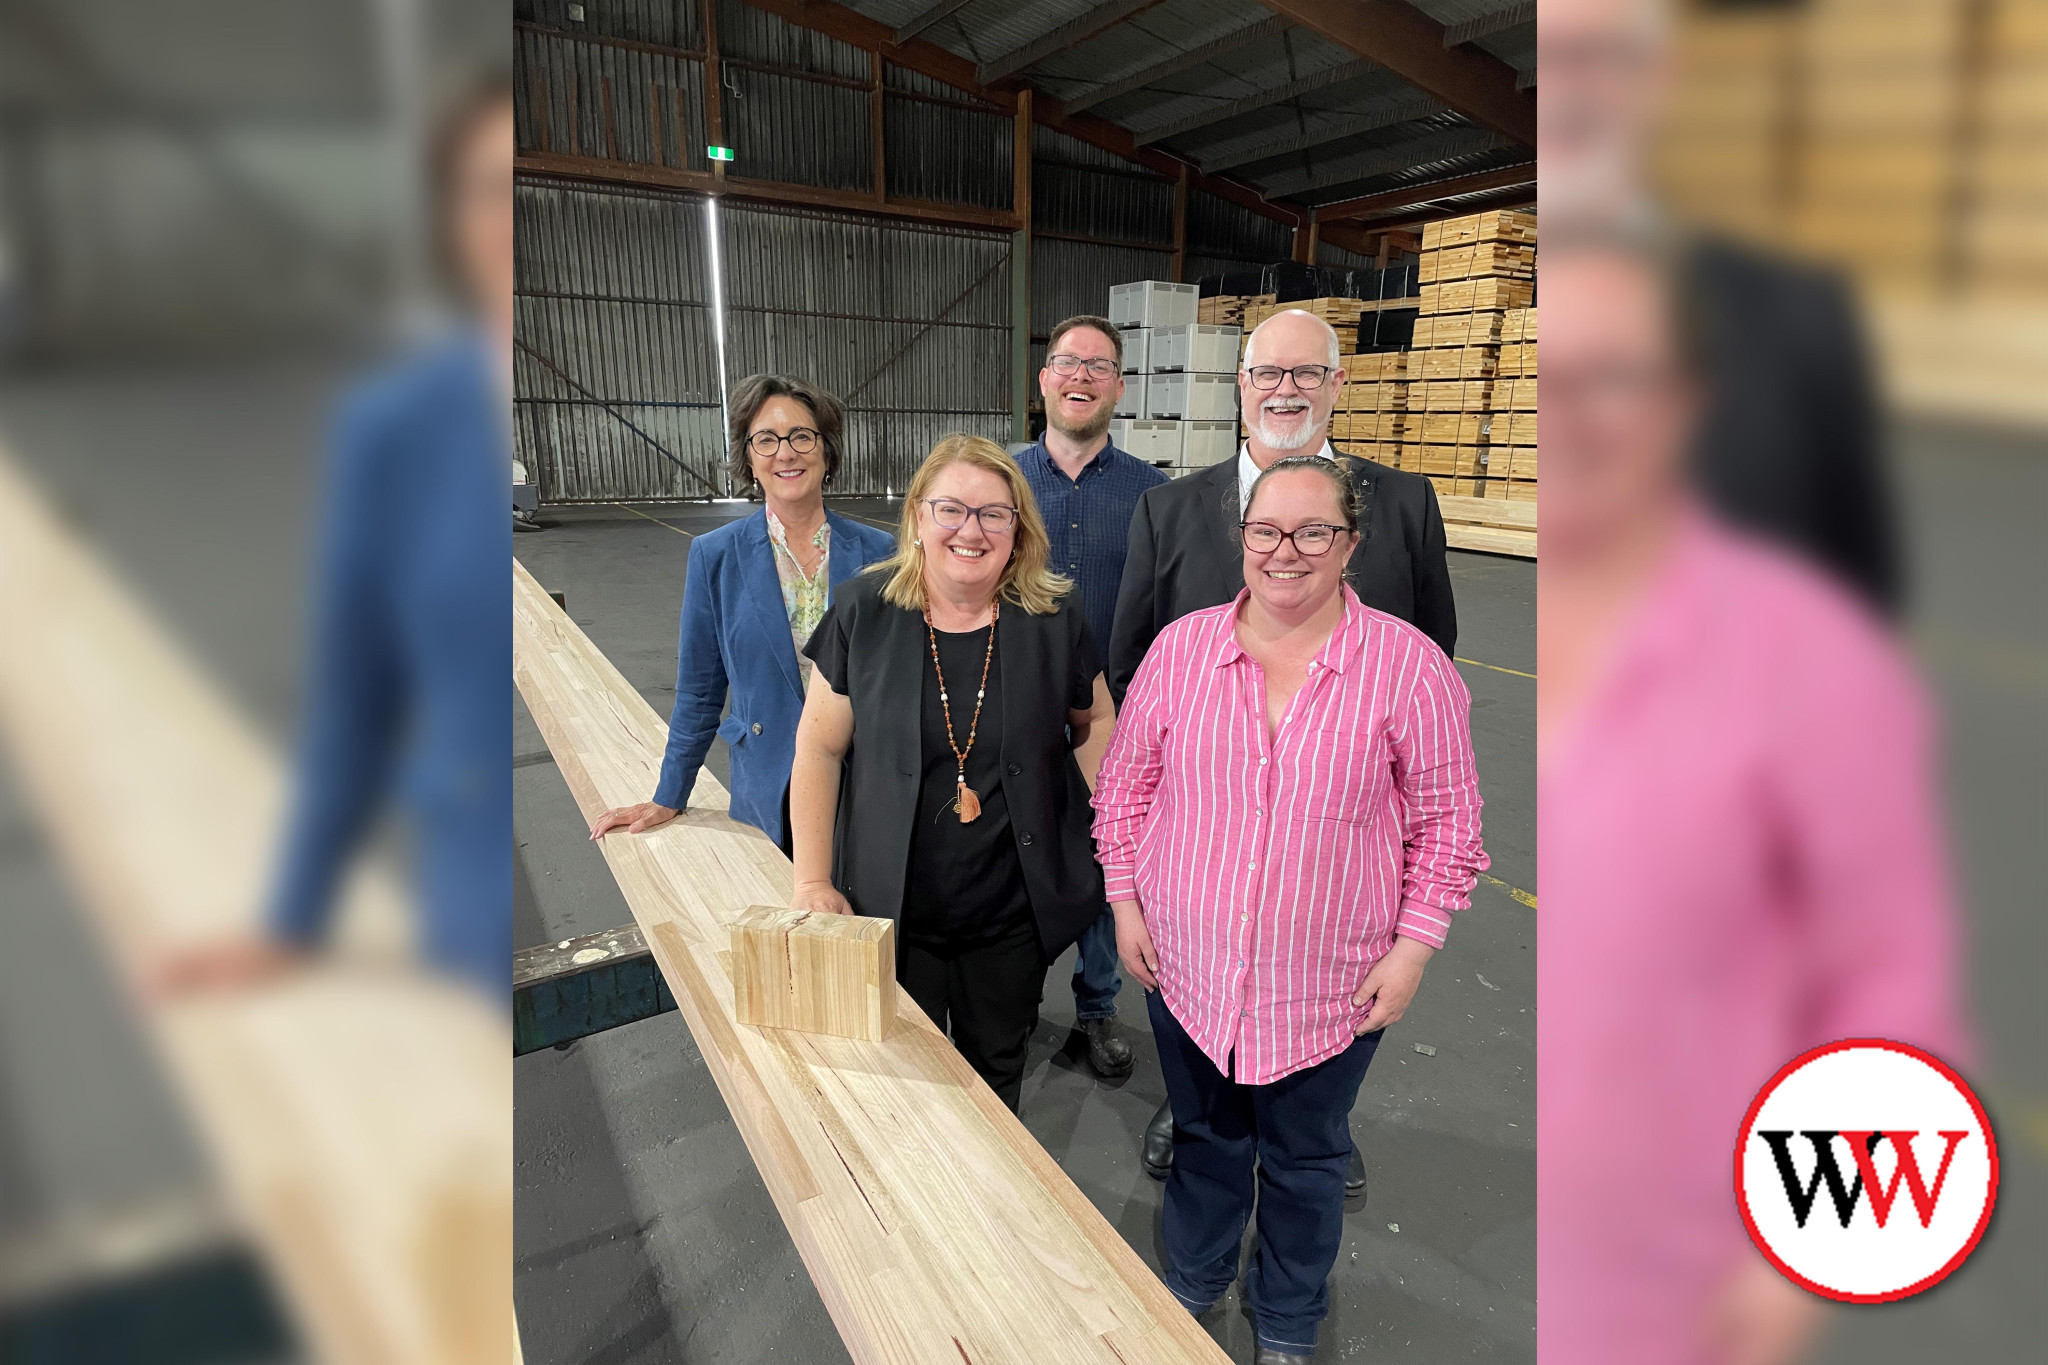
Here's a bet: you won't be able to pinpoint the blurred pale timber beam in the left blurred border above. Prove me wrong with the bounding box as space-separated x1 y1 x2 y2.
0 454 516 1365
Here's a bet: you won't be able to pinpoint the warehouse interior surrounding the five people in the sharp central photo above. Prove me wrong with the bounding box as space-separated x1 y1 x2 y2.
514 0 1536 1361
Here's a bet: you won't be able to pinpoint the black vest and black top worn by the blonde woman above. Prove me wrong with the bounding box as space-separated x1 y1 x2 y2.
805 573 1102 960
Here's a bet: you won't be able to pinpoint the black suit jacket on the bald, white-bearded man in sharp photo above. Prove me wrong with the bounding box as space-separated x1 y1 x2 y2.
1106 454 1458 706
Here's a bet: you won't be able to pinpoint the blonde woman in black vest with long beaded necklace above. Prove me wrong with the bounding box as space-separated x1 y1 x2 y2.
788 436 1114 1109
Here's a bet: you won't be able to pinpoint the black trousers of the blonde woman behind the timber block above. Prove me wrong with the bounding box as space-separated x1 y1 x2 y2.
897 925 1047 1113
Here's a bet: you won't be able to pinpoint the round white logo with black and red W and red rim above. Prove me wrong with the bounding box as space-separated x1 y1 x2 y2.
1735 1040 1999 1304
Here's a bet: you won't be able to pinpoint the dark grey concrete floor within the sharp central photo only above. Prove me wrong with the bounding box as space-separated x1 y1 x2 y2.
514 499 1536 1365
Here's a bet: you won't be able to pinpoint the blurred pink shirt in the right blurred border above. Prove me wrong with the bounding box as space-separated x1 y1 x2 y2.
1536 516 1962 1365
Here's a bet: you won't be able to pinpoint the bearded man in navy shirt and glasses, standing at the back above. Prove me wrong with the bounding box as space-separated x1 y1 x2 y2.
1018 315 1165 1076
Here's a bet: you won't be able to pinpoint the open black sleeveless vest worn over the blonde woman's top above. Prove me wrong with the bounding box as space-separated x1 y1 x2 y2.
811 573 1102 962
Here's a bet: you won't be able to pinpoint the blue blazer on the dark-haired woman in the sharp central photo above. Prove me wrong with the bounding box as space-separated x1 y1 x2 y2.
653 508 895 843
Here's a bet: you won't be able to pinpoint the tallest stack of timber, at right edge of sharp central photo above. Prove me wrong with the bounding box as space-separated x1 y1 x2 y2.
1409 209 1536 497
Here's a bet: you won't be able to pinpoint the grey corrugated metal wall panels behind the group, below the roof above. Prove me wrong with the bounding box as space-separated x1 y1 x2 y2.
516 0 1318 501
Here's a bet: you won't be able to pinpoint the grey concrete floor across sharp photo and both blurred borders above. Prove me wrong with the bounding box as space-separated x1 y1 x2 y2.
0 362 2048 1365
